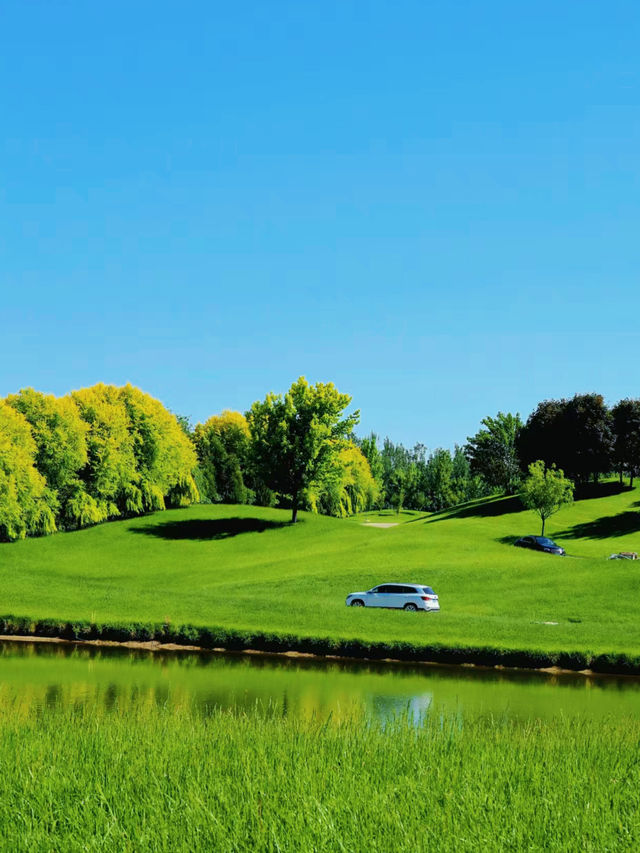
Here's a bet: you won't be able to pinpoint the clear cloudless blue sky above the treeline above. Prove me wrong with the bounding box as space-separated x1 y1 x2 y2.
0 0 640 448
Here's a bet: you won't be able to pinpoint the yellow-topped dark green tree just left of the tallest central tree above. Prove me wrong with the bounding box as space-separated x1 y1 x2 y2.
193 409 254 503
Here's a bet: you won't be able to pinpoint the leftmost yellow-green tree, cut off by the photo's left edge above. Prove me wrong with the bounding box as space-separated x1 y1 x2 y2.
0 400 56 540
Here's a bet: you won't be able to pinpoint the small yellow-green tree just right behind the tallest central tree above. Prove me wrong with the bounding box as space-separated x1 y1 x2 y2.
306 441 380 518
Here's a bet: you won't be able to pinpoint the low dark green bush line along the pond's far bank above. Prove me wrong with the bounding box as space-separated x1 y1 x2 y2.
0 616 640 675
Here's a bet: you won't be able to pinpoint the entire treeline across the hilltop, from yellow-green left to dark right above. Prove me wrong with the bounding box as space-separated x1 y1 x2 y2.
0 377 640 540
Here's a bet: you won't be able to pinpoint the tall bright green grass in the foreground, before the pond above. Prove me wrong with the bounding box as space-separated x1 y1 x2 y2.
0 707 640 853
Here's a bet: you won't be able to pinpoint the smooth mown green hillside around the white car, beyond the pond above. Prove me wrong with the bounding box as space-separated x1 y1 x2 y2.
0 482 640 655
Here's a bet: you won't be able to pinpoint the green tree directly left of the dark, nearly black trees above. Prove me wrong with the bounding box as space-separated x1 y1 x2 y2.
466 412 522 495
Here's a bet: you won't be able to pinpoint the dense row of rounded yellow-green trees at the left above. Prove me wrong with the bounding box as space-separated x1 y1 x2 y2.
0 384 198 540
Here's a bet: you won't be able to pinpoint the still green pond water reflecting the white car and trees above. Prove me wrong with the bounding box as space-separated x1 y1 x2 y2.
0 642 640 721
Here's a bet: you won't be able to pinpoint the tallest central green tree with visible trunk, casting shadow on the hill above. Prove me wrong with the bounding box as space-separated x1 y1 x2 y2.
247 376 359 523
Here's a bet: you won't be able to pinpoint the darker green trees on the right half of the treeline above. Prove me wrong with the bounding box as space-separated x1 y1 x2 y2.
370 394 640 511
